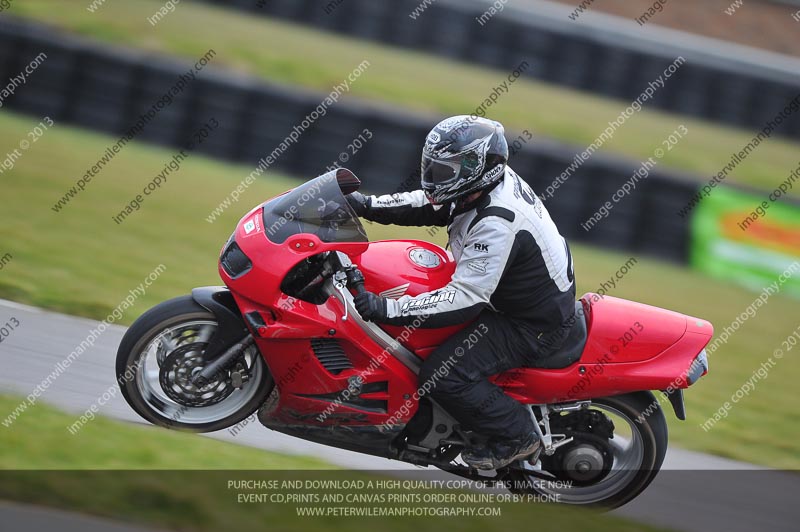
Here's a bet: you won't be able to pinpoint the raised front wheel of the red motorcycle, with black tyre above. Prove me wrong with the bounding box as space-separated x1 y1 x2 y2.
116 296 273 432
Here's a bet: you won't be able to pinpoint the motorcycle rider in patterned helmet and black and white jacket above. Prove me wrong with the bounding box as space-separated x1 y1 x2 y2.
348 116 575 469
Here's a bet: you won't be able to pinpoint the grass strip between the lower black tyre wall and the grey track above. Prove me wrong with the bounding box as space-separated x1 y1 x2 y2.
0 112 800 469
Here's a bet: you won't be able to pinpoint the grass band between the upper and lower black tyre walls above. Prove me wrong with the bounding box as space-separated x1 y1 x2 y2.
9 0 798 196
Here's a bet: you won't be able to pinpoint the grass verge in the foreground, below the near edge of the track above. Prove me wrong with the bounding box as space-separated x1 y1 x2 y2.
0 395 668 532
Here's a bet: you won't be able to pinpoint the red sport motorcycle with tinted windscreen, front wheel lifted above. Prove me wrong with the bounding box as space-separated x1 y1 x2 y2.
116 169 713 507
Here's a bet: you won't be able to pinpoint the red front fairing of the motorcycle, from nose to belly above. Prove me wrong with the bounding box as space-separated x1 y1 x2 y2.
219 208 417 425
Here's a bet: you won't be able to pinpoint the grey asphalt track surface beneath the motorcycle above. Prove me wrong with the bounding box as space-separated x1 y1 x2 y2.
0 300 800 532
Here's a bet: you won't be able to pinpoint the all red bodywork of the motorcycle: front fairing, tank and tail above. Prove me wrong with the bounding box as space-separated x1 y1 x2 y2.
219 181 713 426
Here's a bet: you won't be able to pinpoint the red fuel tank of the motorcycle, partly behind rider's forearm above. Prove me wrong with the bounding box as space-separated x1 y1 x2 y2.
353 240 465 358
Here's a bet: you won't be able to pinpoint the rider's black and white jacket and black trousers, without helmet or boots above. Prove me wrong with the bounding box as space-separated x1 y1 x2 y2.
365 167 575 438
